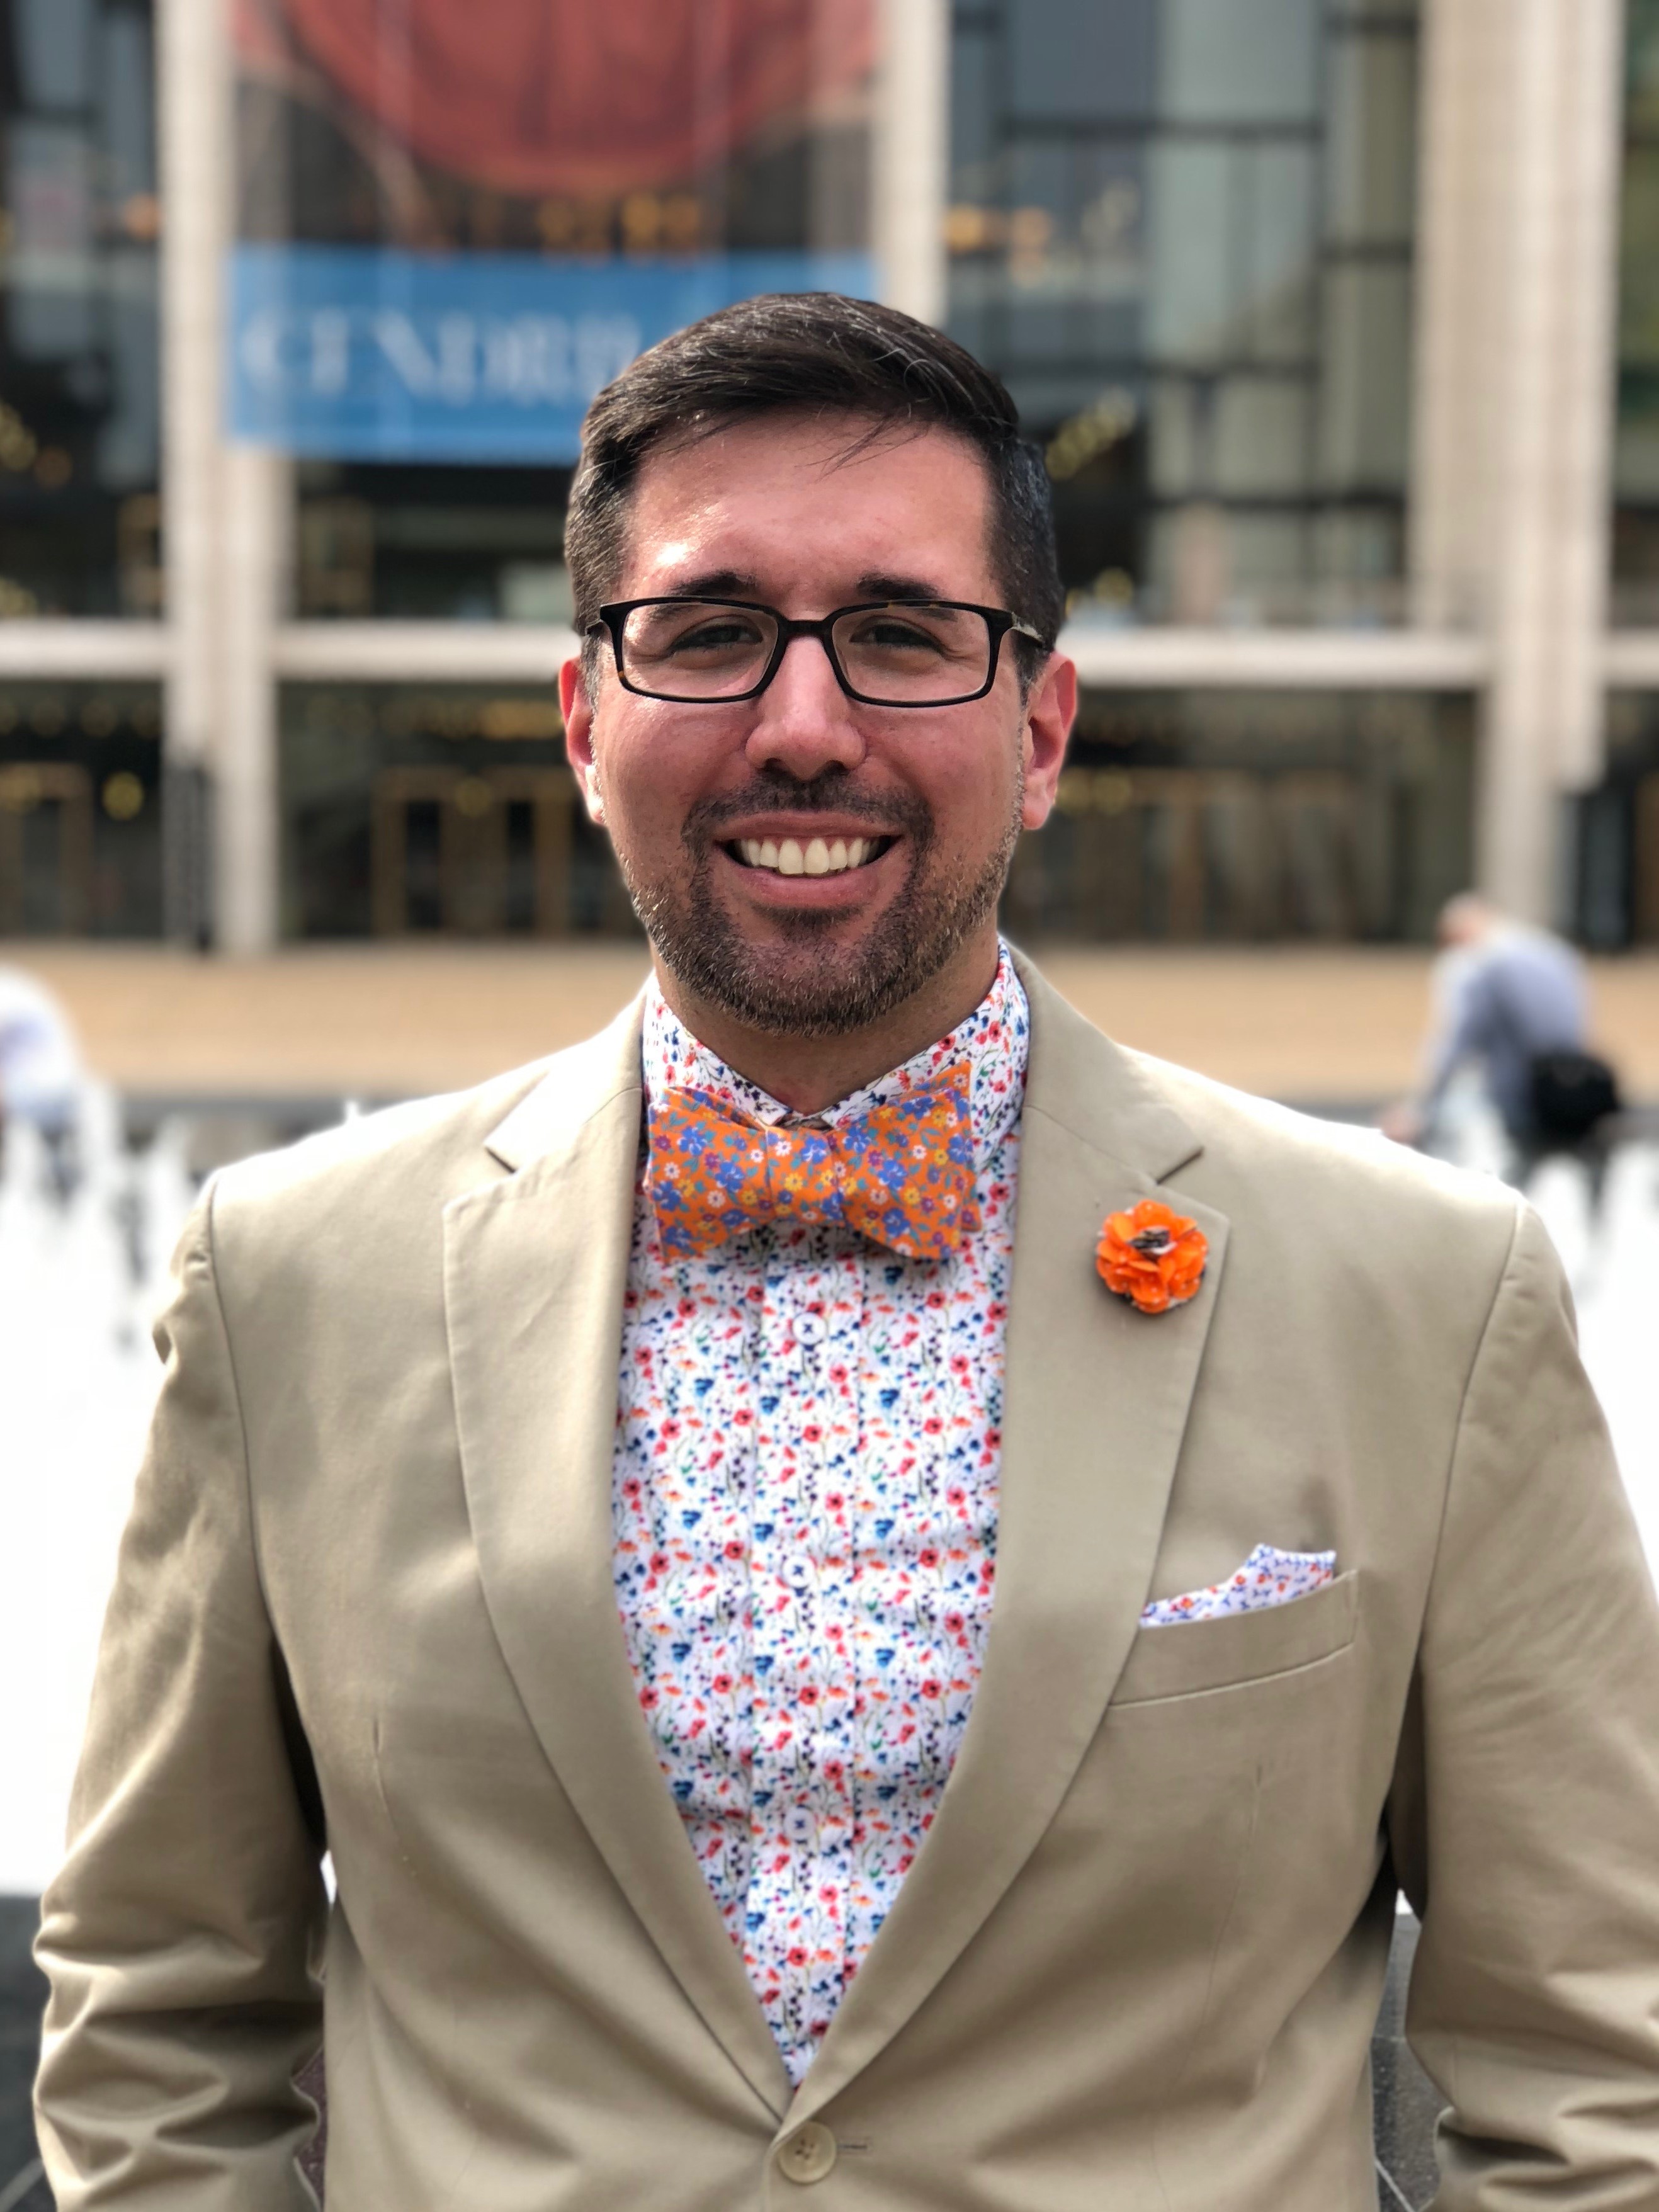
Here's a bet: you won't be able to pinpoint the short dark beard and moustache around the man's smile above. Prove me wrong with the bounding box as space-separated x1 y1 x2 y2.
617 768 1024 1038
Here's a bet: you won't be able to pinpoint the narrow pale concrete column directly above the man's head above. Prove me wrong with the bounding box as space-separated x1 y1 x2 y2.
871 0 951 323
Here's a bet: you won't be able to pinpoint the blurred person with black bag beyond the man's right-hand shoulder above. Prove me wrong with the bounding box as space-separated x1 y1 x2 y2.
1383 892 1619 1215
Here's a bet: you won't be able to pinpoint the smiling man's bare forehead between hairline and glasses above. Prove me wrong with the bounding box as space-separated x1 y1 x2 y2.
621 414 991 602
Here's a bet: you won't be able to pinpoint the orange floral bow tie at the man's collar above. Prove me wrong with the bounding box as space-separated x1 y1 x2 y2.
646 1070 980 1259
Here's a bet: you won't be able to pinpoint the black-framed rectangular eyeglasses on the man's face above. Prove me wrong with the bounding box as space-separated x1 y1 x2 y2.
586 598 1046 706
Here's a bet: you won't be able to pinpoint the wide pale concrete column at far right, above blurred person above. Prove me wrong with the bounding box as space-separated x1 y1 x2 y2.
1412 0 1624 920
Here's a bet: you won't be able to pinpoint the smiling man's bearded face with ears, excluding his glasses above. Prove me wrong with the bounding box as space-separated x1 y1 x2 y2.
562 416 1075 1035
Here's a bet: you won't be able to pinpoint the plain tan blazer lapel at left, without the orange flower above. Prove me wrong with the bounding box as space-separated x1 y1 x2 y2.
444 1004 790 2117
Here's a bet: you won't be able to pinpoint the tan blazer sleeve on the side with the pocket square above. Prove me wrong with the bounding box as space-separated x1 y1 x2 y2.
1391 1208 1659 2212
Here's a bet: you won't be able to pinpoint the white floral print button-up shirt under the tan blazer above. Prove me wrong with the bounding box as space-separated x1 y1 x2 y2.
613 949 1029 2082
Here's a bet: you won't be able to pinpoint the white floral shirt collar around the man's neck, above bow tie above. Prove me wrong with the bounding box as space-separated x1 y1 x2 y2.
642 944 1031 1161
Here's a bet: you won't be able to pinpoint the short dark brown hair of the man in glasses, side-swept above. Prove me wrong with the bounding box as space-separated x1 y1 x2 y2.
564 292 1064 679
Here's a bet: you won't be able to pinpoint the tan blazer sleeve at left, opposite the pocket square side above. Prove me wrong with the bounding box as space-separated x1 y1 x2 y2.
35 1193 327 2212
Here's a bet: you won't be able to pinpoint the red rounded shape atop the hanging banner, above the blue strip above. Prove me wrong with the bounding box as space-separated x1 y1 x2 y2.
239 0 876 197
